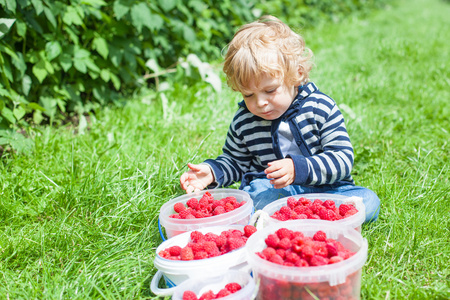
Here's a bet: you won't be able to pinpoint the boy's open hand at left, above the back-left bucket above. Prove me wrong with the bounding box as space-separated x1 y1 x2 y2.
180 164 214 194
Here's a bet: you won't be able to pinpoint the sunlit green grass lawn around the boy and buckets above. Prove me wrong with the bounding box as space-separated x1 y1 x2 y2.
0 0 450 299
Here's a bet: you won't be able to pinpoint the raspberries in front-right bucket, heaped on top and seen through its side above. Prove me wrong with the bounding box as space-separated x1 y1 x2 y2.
254 228 360 300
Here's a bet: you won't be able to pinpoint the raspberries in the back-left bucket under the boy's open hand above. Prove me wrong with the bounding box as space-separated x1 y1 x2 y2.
169 192 247 219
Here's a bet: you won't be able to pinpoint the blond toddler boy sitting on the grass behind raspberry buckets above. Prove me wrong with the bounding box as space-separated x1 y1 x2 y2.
180 16 380 222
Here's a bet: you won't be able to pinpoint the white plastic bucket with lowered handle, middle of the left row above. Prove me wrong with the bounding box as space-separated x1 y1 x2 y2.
150 225 249 296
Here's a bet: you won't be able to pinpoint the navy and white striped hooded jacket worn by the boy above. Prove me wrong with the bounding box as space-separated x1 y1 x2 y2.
205 82 354 188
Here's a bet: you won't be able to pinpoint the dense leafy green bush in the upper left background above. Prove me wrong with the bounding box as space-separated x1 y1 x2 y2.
0 0 253 129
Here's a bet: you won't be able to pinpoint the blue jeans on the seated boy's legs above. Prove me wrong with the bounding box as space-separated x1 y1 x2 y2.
241 178 380 223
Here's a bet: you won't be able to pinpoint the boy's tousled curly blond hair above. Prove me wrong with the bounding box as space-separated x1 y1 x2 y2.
223 16 312 93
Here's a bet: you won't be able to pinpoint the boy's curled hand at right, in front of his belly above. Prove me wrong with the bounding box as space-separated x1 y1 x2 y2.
264 158 295 189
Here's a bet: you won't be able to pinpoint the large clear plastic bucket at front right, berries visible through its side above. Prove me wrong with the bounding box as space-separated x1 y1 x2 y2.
245 220 368 300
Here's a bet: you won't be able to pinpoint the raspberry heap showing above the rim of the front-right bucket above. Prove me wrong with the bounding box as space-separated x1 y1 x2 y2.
256 228 355 267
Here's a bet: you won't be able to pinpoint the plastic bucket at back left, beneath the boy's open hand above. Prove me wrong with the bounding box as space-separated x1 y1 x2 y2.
159 189 254 239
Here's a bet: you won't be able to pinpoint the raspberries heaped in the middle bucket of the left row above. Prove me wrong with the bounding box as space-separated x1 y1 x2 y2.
158 225 256 260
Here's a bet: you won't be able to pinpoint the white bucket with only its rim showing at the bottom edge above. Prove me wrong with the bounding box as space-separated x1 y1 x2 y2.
172 271 255 300
